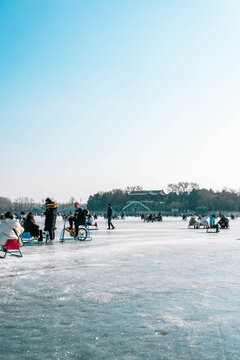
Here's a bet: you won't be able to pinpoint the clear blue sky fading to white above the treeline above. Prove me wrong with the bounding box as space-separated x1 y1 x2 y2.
0 0 240 201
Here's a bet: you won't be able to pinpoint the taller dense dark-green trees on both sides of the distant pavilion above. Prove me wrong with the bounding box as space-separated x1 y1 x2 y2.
87 182 240 212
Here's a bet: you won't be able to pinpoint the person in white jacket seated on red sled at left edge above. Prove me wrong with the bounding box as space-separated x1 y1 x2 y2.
0 211 24 246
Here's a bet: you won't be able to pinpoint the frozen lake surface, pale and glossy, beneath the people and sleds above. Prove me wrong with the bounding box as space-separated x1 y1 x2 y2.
0 218 240 360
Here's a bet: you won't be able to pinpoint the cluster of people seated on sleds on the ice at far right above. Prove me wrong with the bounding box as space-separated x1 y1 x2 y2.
188 214 229 232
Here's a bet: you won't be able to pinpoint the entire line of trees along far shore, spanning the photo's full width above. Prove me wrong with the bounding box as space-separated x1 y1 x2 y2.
0 182 240 212
